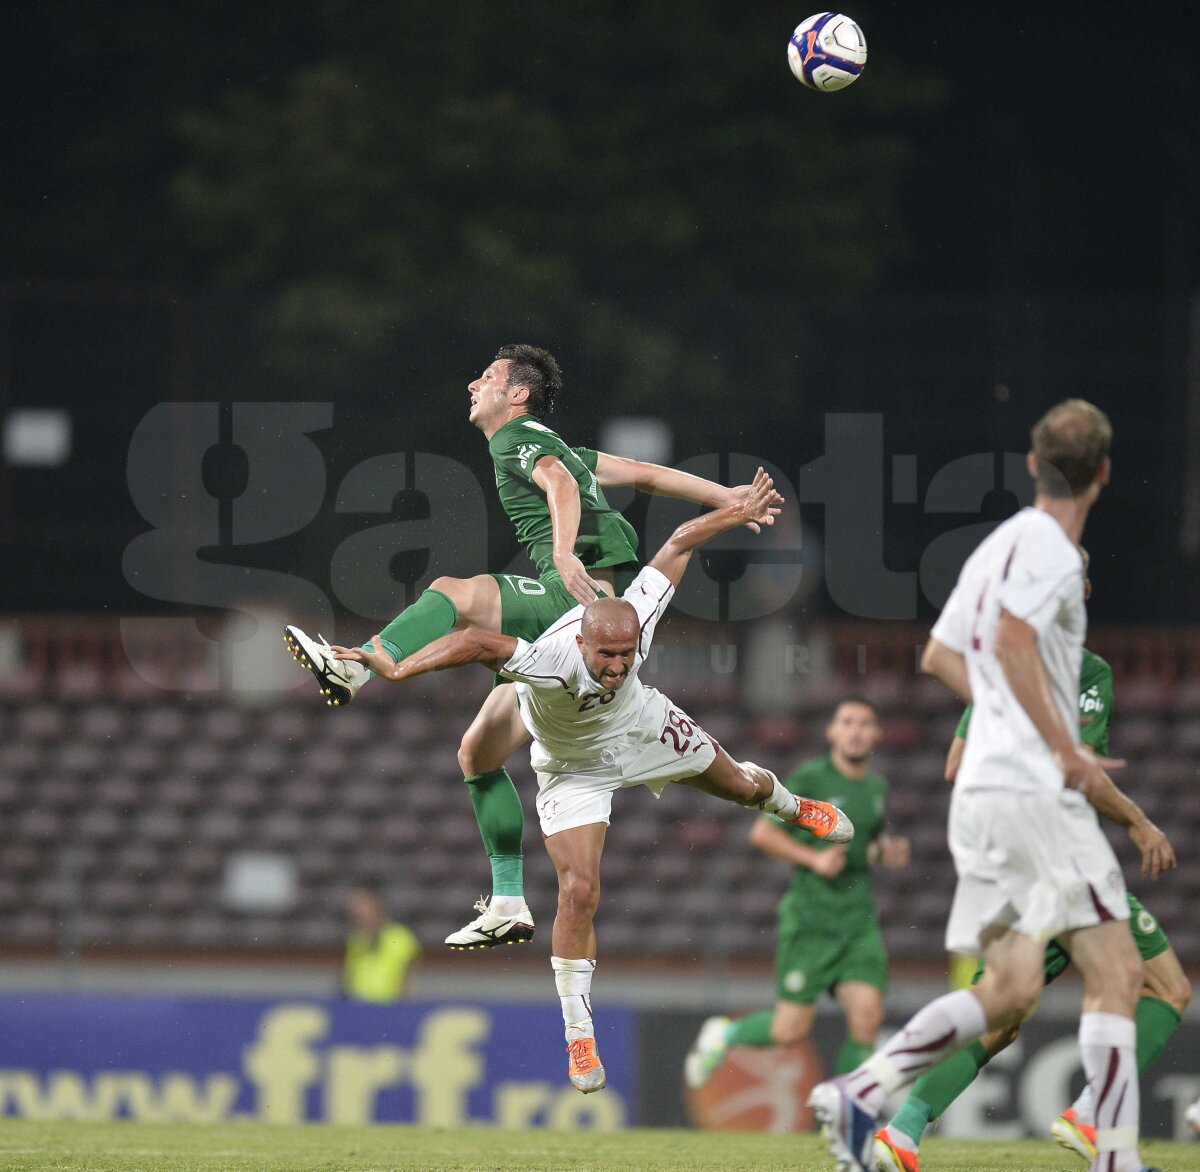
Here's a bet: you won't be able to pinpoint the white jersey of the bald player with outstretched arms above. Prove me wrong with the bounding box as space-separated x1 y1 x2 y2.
500 566 674 773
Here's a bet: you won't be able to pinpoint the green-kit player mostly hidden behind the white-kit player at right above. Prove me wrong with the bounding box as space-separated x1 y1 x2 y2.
875 638 1192 1172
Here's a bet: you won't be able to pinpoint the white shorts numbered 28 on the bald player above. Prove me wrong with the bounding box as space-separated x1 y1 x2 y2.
538 689 718 839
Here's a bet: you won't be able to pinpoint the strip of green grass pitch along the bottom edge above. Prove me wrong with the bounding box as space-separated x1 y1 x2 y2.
0 1119 1185 1172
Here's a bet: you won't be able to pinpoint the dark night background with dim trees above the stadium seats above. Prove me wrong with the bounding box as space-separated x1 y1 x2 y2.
0 0 1200 621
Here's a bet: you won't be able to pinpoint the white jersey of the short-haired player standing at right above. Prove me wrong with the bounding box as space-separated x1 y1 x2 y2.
932 509 1087 792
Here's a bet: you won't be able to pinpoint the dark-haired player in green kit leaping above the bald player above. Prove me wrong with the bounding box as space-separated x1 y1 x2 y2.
284 344 778 949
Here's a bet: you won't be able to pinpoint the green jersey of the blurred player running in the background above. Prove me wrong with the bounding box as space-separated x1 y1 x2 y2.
776 756 888 931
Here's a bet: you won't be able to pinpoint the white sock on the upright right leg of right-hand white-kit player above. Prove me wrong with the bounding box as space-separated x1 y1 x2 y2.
1079 1014 1141 1172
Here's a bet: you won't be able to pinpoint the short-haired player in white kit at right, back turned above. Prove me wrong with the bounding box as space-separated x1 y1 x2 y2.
809 399 1142 1172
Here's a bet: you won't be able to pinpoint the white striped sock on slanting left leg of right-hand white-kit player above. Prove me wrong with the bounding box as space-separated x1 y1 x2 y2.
846 988 988 1114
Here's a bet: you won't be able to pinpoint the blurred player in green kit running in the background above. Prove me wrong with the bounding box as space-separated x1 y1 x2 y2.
684 696 908 1088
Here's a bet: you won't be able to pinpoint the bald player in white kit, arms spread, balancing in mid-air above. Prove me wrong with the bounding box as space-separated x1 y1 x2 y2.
335 468 854 1094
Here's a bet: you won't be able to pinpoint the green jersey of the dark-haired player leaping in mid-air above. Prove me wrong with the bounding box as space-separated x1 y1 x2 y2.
487 415 637 577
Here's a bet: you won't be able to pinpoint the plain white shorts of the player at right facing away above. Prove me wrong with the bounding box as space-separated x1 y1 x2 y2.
946 789 1129 956
